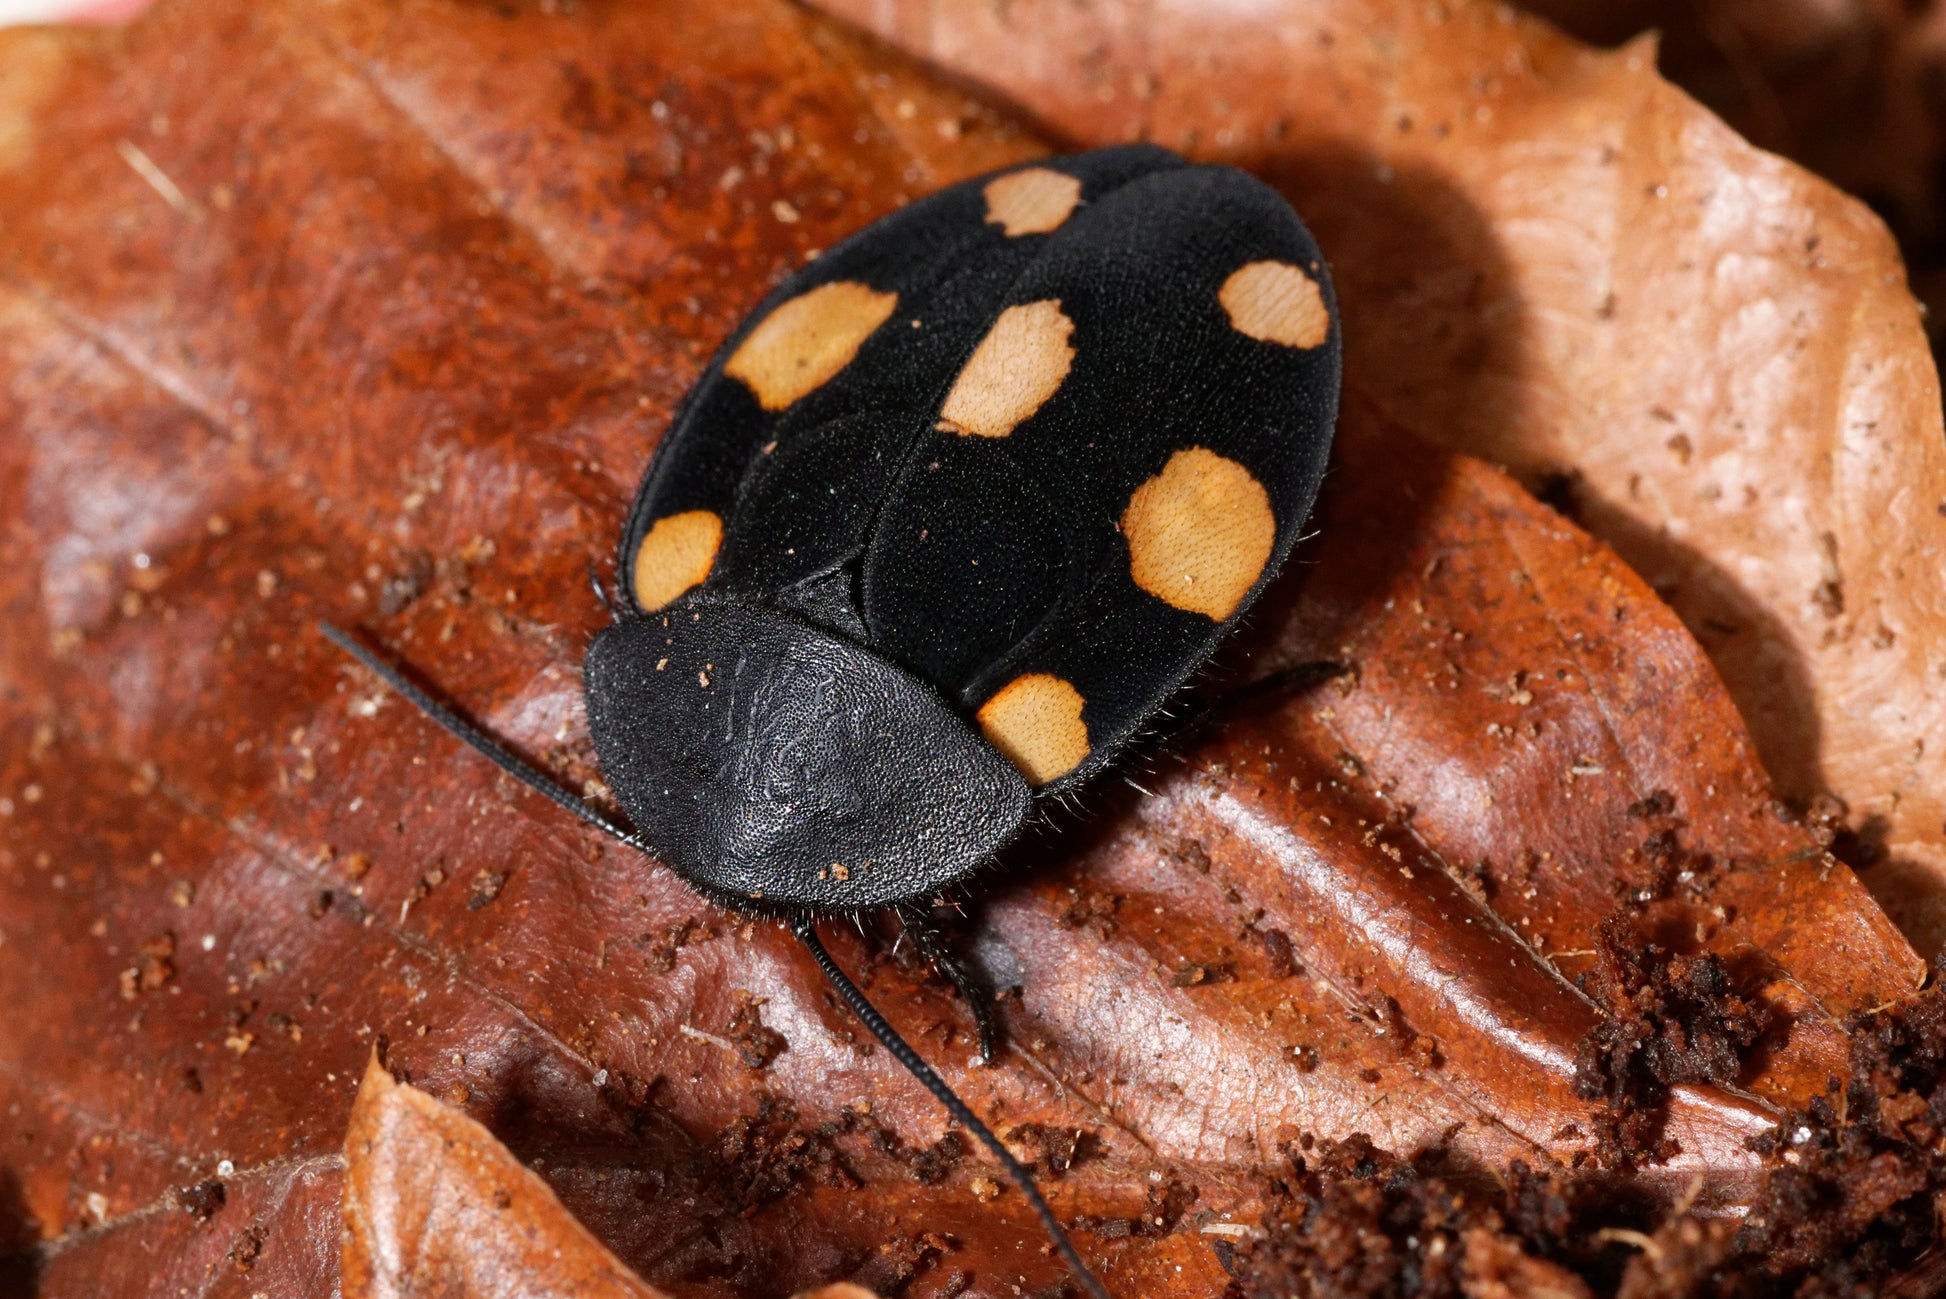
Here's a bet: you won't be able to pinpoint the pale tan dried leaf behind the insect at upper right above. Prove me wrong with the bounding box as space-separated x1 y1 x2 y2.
821 0 1946 953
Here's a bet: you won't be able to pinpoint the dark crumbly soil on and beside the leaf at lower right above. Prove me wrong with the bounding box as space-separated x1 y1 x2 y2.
1228 983 1946 1299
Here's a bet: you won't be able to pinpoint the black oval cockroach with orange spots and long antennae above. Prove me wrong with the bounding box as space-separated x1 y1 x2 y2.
327 146 1339 1293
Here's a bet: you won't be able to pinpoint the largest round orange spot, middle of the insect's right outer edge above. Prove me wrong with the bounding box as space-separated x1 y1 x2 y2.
1121 447 1277 622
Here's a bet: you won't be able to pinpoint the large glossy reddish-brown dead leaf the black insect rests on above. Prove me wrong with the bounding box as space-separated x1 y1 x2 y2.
0 0 1921 1299
